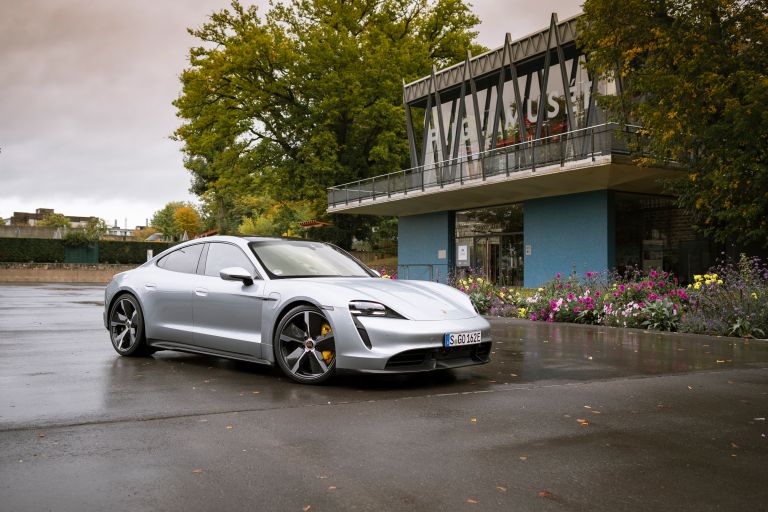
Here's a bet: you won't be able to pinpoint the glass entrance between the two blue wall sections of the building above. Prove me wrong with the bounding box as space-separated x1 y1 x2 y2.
456 204 523 286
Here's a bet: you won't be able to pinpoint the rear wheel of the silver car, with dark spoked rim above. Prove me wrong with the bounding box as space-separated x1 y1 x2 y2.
108 293 154 357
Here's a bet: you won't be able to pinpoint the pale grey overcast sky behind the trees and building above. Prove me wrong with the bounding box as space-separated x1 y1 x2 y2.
0 0 582 227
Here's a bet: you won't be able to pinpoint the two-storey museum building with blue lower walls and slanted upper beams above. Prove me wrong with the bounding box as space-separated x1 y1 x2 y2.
328 14 711 287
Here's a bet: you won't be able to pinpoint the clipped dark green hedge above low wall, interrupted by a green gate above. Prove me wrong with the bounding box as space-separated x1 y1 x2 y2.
0 238 174 264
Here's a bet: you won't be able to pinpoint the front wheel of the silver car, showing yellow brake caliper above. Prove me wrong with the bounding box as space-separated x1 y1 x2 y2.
273 305 336 384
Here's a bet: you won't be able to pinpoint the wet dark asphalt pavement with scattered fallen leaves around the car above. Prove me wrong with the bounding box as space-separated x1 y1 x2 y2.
0 285 768 512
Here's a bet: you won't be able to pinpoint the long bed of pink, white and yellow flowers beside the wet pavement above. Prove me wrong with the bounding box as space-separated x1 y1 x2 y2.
452 256 768 337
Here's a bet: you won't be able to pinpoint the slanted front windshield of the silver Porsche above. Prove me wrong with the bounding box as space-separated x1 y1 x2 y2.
250 240 374 279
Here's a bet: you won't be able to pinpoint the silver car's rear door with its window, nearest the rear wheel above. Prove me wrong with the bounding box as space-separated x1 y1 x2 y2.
144 243 205 344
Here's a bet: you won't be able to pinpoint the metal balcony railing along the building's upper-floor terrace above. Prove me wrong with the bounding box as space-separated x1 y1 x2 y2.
328 123 639 208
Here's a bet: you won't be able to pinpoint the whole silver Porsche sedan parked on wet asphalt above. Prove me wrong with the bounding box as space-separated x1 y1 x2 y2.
104 236 491 384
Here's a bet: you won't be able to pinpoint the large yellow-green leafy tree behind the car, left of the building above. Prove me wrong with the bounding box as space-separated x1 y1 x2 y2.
174 0 482 244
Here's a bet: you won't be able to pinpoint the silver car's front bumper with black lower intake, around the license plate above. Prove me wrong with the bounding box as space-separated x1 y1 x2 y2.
334 313 492 373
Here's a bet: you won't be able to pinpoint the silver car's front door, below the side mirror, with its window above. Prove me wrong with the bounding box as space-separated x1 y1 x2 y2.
193 242 267 358
